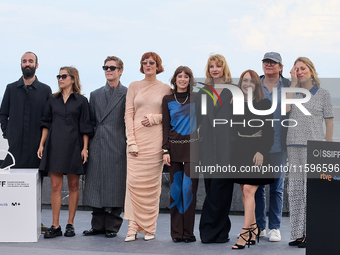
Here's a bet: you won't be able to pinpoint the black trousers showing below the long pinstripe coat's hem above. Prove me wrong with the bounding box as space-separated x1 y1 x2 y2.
91 207 123 233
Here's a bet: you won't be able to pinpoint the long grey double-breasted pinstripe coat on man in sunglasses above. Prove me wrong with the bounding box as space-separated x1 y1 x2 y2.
83 83 127 208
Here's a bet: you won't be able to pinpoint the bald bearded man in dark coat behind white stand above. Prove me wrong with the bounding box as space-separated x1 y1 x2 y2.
0 52 52 168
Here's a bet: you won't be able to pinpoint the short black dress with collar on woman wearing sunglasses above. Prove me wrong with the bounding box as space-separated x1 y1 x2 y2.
39 93 93 175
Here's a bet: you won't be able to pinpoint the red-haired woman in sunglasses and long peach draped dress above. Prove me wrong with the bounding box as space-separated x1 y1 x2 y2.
124 52 171 242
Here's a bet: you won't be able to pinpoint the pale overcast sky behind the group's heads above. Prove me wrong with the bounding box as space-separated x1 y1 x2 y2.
0 0 340 97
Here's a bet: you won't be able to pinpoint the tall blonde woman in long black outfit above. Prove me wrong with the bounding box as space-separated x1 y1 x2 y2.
195 54 234 243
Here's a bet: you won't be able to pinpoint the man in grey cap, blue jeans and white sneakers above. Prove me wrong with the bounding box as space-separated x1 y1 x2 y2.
255 52 290 242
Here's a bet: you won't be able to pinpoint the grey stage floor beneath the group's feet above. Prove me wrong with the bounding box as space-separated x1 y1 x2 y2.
0 209 306 255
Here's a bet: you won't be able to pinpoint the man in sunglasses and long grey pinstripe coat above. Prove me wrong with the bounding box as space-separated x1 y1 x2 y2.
83 56 127 238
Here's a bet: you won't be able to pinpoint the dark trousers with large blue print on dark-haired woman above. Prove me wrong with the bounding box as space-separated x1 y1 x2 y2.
169 162 198 240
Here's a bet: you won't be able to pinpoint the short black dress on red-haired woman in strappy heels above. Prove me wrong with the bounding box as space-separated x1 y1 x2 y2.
232 99 274 185
